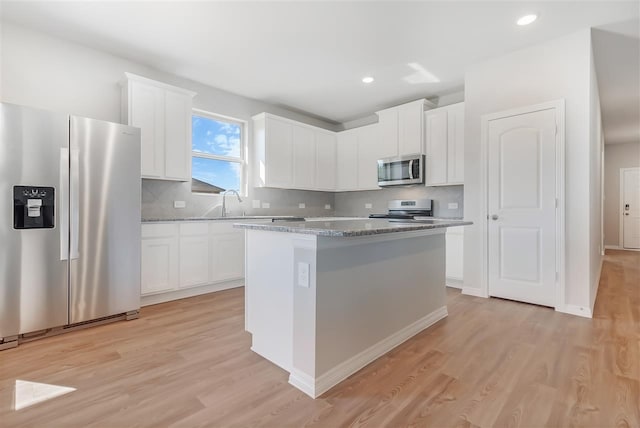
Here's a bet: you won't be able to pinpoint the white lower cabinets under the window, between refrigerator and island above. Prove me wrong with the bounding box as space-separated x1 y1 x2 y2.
141 220 251 306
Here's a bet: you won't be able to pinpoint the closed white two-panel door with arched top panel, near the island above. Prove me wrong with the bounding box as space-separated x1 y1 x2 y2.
488 108 556 306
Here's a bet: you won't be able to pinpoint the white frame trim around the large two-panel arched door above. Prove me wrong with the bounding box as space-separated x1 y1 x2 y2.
480 99 565 311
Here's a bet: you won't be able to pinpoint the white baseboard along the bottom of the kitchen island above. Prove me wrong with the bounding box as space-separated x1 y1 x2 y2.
289 306 448 398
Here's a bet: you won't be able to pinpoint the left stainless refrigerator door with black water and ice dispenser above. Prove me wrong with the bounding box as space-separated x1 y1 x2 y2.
0 103 69 339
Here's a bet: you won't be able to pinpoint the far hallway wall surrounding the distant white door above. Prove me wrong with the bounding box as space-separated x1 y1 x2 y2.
604 141 640 247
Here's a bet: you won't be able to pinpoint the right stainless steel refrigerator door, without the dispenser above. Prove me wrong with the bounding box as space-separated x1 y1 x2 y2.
69 116 141 324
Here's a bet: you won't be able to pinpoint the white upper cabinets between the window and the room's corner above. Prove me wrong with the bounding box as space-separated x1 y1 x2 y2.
253 113 336 191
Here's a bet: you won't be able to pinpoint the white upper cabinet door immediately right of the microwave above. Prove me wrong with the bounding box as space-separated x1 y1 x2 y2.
425 109 447 186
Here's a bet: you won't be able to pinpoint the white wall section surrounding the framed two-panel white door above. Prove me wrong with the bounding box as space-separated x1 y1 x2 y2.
464 29 591 310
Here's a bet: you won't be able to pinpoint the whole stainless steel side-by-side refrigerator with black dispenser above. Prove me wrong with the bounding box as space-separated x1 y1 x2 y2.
0 103 141 349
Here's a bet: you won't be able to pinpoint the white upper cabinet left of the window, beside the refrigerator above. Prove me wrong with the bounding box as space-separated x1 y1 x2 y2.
122 73 196 181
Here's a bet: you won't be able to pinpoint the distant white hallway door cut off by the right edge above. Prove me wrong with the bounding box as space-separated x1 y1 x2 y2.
622 168 640 249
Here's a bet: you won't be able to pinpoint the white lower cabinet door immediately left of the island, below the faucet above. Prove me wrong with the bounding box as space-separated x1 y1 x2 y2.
211 230 244 282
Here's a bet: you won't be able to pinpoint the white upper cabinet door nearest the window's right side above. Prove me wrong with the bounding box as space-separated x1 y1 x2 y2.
265 117 293 189
